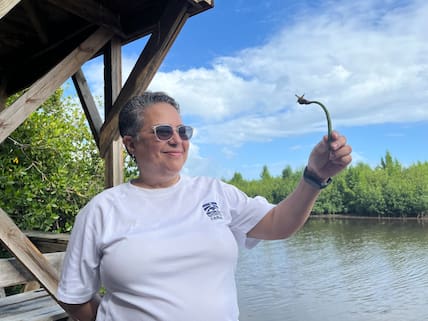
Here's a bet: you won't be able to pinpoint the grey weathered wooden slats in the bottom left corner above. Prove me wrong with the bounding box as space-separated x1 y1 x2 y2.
0 289 67 321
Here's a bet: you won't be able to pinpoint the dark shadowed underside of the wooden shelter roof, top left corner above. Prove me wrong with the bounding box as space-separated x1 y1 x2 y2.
0 0 212 96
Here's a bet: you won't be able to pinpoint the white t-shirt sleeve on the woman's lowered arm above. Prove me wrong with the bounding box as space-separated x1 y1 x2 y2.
57 202 101 304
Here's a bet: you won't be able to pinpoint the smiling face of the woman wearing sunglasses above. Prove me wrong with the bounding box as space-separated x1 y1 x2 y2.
124 103 190 187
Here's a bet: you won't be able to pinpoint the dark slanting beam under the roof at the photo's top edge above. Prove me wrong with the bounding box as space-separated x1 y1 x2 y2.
48 0 126 38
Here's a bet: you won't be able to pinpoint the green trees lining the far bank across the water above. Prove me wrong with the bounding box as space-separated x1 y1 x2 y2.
224 155 428 217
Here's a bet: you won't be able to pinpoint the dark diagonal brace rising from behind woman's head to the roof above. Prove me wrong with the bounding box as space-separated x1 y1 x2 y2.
100 0 189 157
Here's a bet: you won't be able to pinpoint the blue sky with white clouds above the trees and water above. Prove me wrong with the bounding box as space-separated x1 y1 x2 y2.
72 0 428 179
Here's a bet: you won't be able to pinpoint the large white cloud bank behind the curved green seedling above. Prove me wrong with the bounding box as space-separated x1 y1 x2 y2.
145 1 428 145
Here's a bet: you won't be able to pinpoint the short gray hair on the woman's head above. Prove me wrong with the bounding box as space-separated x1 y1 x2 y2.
119 91 180 137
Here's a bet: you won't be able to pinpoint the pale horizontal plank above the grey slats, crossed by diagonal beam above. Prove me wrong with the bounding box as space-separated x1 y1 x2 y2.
0 252 65 288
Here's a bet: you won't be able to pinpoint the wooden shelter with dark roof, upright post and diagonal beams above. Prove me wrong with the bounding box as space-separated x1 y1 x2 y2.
0 0 214 318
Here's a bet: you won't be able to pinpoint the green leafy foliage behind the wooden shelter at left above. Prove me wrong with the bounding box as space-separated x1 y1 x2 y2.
0 90 104 232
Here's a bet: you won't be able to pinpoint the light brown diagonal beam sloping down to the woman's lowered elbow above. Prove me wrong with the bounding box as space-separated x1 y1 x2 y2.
0 208 58 297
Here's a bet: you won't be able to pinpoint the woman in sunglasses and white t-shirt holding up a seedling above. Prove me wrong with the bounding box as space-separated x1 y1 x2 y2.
58 92 351 321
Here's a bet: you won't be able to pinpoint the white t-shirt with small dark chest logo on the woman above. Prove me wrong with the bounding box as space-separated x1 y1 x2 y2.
57 176 273 321
